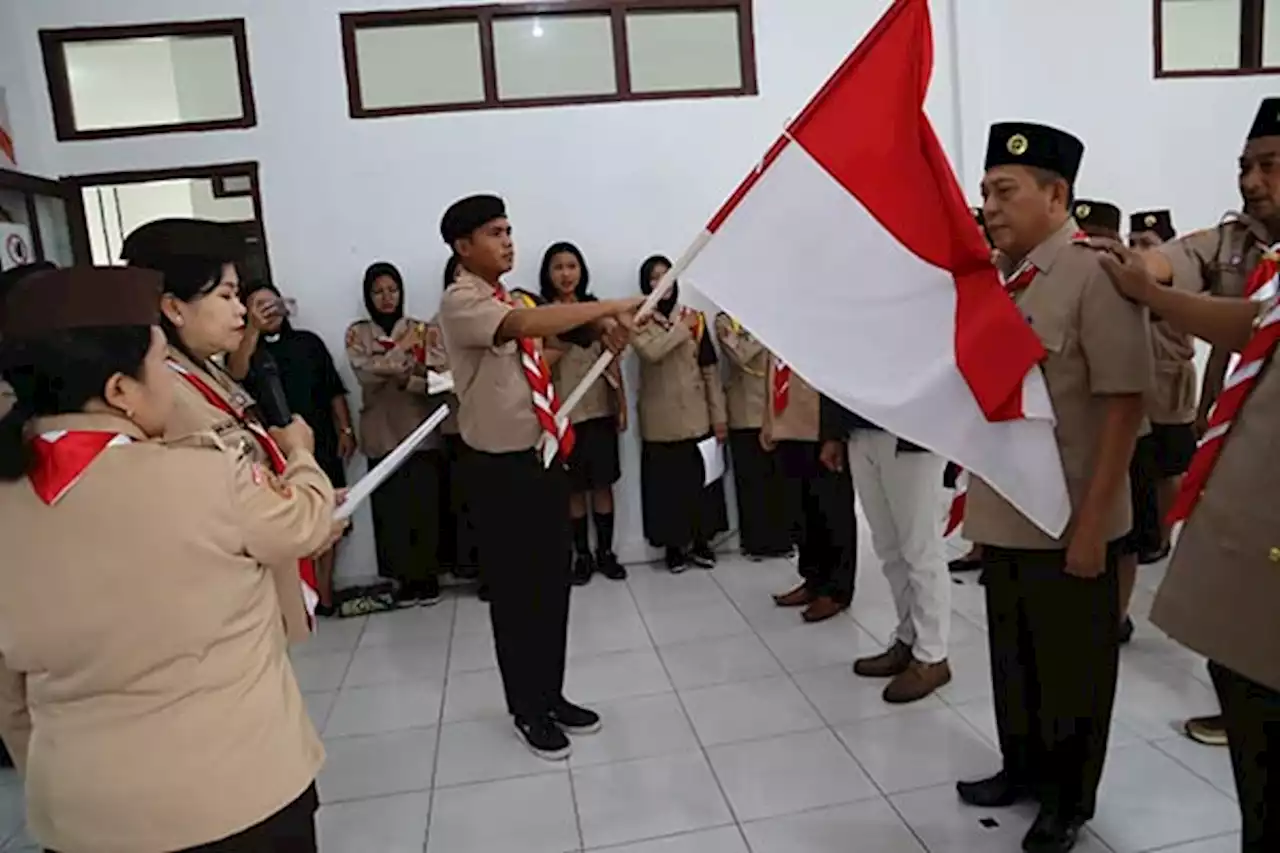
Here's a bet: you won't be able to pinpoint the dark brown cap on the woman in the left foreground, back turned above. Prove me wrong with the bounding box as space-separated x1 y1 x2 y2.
0 266 163 341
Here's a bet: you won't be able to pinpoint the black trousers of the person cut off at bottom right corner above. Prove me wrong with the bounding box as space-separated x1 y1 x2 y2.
1208 661 1280 853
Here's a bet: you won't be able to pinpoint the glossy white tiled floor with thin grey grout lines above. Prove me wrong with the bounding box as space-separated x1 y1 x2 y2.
0 537 1239 853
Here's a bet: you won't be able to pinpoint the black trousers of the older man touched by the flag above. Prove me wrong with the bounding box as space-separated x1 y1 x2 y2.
982 543 1120 820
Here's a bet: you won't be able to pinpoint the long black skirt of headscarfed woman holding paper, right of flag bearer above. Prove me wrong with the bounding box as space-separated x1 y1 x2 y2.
640 438 728 548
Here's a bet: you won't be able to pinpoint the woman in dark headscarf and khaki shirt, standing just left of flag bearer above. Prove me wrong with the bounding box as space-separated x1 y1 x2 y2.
347 263 447 605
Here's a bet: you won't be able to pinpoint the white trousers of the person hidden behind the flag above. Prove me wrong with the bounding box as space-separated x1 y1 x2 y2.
849 429 951 663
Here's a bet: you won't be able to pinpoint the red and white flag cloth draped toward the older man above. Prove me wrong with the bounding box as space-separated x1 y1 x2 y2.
689 0 1070 535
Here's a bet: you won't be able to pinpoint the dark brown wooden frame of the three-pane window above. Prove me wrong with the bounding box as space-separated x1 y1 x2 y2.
340 0 759 119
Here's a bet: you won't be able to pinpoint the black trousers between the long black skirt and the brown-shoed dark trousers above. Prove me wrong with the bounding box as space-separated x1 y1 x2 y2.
728 429 791 557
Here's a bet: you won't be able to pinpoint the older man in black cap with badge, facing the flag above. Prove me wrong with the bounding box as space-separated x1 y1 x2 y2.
957 123 1151 853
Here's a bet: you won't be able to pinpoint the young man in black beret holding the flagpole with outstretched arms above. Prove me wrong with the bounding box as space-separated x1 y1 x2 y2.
440 196 640 761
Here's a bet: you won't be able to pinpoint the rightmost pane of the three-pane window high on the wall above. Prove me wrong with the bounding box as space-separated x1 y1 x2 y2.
627 10 742 92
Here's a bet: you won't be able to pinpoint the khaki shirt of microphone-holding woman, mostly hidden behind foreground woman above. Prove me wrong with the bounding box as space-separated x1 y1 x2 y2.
165 348 311 643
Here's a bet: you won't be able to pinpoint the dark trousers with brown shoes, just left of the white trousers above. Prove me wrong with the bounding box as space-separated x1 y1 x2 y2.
774 441 858 605
